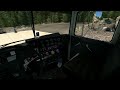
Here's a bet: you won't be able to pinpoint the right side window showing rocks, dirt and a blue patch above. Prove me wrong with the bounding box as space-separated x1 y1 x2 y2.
75 11 120 42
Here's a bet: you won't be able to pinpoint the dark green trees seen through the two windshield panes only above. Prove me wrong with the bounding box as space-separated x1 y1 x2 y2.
0 11 71 27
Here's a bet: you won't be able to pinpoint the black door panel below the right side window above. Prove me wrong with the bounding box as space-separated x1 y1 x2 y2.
65 36 113 79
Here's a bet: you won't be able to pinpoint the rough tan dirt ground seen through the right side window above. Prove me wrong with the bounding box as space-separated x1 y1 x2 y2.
75 25 114 42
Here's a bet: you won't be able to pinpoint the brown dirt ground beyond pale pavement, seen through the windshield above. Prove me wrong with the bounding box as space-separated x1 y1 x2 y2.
3 23 69 34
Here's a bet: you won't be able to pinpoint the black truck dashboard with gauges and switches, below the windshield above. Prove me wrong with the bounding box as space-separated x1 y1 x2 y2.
0 33 65 78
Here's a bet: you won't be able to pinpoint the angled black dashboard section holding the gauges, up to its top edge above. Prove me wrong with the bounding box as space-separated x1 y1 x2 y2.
26 33 62 68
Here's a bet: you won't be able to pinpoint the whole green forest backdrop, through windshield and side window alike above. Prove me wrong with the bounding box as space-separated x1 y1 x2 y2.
0 11 120 28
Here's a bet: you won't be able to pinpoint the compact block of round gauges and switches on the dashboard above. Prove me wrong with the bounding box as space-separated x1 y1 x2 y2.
39 37 61 60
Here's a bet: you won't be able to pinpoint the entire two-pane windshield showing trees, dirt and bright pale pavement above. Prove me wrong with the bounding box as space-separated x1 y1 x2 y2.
0 11 71 46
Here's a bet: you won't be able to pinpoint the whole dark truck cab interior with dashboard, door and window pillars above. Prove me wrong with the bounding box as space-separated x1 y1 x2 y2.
0 11 120 80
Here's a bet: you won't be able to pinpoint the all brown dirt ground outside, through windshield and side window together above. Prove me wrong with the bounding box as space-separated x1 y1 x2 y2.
0 23 114 42
